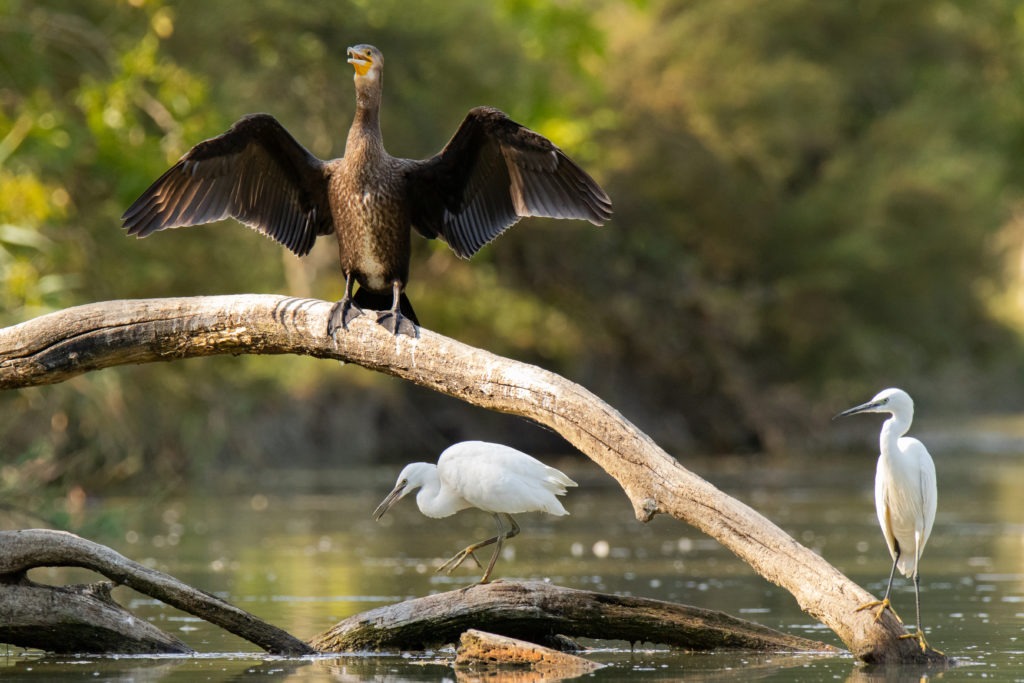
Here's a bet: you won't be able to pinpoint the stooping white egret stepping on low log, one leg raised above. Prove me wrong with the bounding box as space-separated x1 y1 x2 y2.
374 441 577 584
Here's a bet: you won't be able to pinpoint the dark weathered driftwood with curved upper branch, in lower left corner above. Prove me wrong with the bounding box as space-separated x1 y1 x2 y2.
0 529 314 654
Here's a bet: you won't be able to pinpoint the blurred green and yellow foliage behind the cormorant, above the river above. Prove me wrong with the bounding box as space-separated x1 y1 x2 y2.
0 0 1024 507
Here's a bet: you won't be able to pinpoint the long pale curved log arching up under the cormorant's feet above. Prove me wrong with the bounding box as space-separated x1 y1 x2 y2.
0 295 948 664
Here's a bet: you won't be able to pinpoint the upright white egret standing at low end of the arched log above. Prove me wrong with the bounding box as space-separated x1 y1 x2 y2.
836 389 938 651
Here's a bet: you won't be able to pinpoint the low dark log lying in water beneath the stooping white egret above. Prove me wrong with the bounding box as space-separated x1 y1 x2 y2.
310 581 836 652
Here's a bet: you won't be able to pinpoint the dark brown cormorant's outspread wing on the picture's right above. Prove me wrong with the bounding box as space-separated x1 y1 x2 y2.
408 106 611 258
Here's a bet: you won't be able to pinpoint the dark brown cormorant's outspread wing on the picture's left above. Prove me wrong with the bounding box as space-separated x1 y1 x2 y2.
122 114 333 256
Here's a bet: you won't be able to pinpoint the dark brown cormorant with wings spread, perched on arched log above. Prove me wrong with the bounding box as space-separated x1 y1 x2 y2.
122 45 611 335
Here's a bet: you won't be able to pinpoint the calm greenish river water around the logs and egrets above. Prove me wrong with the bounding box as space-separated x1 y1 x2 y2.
0 424 1024 681
